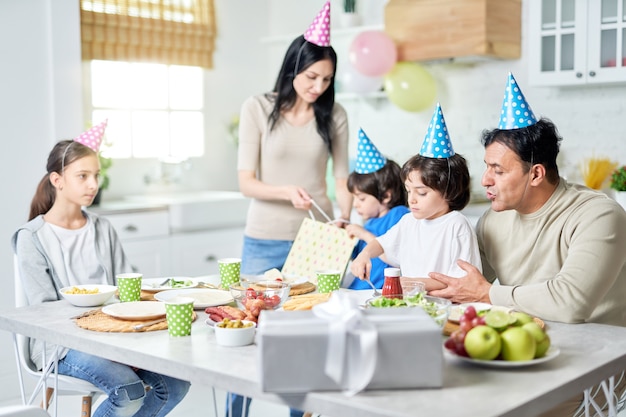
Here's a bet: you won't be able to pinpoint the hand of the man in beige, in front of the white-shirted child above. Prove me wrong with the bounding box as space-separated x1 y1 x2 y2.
428 260 491 304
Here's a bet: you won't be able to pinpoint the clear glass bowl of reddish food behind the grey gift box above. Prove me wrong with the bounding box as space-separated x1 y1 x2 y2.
229 281 291 310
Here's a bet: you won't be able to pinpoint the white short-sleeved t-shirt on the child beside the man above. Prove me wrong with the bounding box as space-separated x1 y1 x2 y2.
377 211 482 278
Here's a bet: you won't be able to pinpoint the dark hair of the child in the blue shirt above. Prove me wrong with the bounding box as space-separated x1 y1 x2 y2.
348 159 407 209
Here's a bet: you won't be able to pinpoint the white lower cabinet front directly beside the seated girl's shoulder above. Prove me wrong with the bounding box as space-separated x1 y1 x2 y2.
105 207 174 277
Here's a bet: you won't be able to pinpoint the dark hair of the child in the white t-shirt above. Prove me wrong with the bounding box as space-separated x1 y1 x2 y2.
400 153 470 210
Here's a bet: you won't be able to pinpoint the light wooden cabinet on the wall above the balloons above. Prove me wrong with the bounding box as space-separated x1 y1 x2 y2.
385 0 520 61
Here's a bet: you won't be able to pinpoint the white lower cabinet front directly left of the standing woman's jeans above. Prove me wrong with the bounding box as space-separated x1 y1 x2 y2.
170 227 244 276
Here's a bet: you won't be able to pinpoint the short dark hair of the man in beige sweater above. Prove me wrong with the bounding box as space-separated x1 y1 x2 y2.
481 118 563 184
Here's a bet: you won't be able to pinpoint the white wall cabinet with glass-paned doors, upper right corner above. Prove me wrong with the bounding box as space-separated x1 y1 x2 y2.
528 0 626 86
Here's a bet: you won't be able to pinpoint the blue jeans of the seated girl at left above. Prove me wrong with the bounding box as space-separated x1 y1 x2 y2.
59 350 190 417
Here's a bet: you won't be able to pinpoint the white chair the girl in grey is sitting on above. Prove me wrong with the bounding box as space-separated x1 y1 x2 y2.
12 256 104 417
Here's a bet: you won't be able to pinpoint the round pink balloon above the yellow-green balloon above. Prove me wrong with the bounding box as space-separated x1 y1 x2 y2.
348 30 398 77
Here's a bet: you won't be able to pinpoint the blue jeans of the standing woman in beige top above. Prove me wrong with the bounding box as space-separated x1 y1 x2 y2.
226 236 304 417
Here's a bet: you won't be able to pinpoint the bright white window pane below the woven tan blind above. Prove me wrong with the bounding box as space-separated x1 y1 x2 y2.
85 60 204 160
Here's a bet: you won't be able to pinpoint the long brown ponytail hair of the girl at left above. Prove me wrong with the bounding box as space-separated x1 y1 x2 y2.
28 140 95 221
